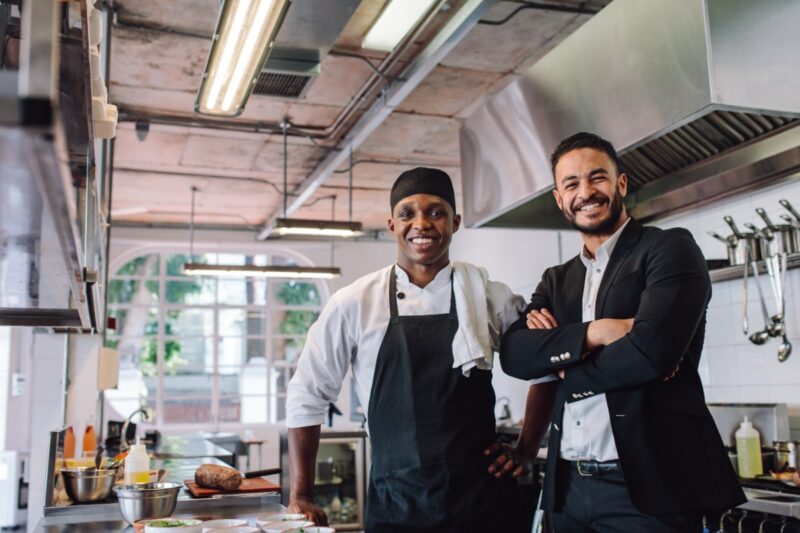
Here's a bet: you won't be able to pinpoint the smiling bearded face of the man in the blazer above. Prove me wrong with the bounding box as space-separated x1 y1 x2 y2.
553 148 628 235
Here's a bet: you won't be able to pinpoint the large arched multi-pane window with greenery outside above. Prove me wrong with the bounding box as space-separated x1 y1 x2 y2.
106 250 327 428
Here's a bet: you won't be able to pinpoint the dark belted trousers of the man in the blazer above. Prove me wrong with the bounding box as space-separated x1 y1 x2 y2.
553 463 703 533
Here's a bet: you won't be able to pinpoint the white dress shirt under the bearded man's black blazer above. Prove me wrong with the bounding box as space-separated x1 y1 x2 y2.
561 219 630 461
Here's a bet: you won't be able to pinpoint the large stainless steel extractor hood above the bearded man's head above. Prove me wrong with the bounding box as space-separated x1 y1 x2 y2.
461 0 800 228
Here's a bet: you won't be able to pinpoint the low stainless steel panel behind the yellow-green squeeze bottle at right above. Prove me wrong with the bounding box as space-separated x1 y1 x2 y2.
708 403 789 448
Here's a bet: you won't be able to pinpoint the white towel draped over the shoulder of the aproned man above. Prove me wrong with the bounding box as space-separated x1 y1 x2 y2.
451 261 500 376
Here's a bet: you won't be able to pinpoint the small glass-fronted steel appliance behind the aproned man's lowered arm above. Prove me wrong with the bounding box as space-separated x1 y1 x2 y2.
280 431 370 531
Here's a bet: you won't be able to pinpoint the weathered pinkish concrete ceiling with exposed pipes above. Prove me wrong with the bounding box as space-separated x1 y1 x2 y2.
104 0 607 232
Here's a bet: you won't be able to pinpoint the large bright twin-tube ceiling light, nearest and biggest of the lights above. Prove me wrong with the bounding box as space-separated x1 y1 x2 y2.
194 0 291 117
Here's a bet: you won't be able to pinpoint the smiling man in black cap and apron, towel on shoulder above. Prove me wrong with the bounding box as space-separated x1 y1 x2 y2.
286 168 549 533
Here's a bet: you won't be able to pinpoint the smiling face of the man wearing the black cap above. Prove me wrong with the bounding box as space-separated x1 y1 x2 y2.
389 194 461 268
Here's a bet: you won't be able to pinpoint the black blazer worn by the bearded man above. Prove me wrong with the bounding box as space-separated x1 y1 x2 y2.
500 220 746 515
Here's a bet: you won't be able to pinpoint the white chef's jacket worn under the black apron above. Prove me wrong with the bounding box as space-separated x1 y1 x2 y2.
286 265 546 428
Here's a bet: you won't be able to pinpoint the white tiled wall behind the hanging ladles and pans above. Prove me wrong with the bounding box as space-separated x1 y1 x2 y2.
657 177 800 415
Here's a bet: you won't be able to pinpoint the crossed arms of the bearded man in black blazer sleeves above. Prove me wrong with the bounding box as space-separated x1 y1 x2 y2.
500 230 711 393
